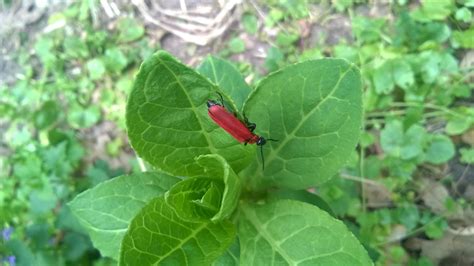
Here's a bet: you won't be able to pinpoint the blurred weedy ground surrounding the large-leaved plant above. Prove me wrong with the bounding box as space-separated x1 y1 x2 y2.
0 0 474 266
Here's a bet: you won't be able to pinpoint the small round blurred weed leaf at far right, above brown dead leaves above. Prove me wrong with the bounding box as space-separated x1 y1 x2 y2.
425 135 455 164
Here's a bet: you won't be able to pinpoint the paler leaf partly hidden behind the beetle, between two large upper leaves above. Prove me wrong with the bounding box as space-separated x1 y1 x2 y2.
197 56 252 110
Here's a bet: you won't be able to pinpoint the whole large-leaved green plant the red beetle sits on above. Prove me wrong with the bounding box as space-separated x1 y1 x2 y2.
70 51 372 265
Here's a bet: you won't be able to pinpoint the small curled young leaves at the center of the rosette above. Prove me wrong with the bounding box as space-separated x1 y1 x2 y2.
165 154 241 221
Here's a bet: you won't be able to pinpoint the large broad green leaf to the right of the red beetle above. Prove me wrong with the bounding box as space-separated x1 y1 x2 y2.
244 59 362 189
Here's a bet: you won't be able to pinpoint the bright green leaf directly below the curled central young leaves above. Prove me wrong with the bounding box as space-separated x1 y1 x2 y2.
119 197 235 265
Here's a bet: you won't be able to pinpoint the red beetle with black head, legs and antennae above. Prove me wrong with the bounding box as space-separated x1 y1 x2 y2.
207 96 277 168
